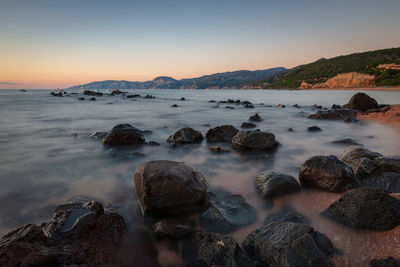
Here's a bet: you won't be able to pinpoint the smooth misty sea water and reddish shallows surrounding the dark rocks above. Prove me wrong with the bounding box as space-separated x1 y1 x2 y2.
0 90 400 265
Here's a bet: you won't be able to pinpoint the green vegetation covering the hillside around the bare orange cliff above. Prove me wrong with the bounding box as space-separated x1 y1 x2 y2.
253 48 400 88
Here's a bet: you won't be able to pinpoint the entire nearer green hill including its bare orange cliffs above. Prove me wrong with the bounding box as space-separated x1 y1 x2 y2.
253 48 400 89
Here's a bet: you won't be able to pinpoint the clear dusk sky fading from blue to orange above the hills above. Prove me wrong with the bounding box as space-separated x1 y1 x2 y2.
0 0 400 89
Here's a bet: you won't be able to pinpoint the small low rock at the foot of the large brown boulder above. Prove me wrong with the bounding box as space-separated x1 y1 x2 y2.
152 220 192 239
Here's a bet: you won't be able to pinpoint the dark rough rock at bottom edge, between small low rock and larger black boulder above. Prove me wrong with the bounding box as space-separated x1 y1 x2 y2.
182 231 257 267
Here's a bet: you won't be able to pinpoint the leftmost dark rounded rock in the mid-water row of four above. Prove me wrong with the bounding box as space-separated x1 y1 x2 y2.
103 124 145 145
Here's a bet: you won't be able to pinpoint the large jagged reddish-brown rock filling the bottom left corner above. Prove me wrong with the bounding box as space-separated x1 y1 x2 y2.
0 201 126 266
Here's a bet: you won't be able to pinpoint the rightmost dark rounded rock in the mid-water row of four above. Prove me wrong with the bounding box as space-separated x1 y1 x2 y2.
232 131 279 150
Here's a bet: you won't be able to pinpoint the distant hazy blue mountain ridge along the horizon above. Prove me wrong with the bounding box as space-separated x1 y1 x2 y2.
68 67 286 90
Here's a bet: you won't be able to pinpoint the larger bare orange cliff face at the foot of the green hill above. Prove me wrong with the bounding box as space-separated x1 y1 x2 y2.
299 72 375 89
